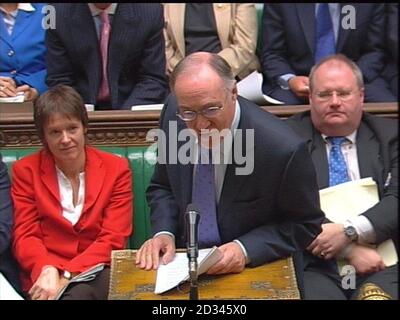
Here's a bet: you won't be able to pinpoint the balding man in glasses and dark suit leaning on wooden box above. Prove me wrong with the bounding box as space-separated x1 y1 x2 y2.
137 52 322 274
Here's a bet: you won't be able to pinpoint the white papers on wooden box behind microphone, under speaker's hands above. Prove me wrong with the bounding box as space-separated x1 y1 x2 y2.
154 247 222 294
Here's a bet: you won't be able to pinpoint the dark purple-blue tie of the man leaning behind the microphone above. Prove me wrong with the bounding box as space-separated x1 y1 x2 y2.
192 148 221 248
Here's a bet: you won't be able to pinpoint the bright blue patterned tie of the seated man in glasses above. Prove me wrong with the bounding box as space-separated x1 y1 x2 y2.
328 137 349 187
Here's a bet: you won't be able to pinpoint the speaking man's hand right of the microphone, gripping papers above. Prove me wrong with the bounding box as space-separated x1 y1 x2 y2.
207 242 246 274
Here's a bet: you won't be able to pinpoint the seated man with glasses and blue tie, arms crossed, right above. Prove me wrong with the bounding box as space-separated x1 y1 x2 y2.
288 55 398 299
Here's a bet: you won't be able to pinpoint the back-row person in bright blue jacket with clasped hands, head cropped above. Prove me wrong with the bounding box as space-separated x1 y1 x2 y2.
0 3 47 101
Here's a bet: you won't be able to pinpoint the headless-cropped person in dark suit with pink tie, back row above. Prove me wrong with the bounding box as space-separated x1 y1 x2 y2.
46 3 167 110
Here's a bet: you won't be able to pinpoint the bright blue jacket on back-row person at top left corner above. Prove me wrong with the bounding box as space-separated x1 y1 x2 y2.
0 3 47 94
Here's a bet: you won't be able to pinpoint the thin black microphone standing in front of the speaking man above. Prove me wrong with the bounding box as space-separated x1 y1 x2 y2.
185 203 200 300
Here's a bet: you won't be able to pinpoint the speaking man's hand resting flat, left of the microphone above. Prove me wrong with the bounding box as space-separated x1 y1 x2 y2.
136 234 175 270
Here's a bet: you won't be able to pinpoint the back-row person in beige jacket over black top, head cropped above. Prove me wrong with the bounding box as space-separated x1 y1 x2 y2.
164 3 260 79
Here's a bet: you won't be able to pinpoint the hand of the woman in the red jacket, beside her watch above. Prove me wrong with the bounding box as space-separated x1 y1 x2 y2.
28 266 63 300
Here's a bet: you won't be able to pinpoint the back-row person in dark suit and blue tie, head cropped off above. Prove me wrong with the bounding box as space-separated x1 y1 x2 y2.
261 3 396 104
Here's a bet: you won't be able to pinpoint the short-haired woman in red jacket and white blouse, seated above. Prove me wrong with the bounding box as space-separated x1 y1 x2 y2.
12 85 133 300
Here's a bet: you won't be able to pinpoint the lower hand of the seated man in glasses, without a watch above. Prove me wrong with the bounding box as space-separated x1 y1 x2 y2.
346 245 385 274
